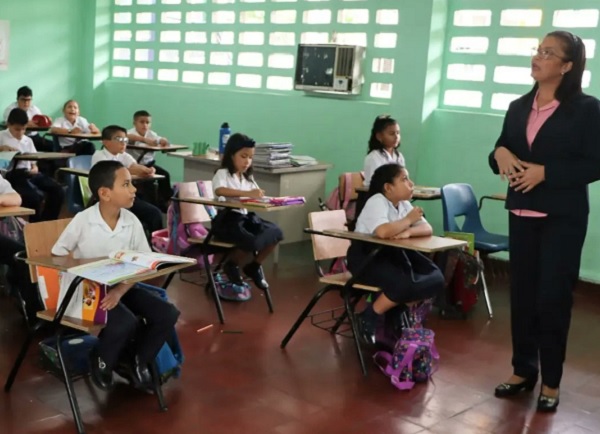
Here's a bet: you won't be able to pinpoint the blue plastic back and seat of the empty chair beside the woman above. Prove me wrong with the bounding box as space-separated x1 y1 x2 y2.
442 184 508 253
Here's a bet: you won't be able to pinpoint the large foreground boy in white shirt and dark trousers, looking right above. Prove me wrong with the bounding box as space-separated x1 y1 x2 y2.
52 161 179 389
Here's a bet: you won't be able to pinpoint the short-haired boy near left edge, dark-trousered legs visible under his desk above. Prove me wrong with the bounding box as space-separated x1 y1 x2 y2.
0 108 65 222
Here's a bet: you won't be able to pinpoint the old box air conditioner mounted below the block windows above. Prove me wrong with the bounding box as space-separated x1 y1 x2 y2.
294 44 365 95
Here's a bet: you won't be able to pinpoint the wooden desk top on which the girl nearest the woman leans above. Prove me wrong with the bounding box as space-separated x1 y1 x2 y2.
314 229 467 253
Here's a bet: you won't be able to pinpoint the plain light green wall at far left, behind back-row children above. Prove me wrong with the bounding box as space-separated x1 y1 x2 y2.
0 0 92 118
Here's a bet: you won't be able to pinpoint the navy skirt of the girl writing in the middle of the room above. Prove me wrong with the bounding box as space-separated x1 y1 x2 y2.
212 209 283 252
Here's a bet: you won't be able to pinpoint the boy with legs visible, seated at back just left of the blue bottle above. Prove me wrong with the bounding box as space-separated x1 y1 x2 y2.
127 110 173 212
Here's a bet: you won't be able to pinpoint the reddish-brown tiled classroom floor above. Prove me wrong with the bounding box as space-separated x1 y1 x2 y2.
0 244 600 434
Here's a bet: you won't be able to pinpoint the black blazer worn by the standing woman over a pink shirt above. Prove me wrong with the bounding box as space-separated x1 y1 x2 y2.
489 90 600 215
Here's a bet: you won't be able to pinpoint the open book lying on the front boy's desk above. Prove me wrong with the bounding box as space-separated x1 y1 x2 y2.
67 250 196 285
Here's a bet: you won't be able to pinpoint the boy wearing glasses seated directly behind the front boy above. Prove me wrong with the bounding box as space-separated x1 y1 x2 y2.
92 125 163 238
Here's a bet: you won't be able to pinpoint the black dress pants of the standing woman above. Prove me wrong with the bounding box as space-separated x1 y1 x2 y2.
509 213 588 389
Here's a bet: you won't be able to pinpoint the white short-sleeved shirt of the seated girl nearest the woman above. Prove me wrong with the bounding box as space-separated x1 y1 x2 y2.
354 193 427 235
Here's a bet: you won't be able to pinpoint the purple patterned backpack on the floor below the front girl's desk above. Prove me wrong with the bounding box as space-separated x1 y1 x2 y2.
373 328 440 390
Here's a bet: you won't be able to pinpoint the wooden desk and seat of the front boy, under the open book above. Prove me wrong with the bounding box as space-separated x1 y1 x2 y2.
4 256 194 433
